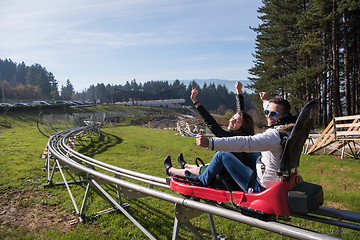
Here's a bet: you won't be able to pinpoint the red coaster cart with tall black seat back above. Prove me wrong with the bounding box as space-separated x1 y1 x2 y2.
170 101 324 218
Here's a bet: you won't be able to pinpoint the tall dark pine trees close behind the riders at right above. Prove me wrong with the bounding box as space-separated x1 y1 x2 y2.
249 0 360 125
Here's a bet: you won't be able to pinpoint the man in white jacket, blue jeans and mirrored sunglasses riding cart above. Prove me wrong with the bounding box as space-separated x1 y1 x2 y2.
164 95 296 192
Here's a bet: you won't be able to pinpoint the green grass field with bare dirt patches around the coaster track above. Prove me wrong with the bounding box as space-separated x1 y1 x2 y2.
0 108 360 239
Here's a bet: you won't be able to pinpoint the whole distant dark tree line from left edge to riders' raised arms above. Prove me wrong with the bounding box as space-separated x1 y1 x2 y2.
0 59 251 113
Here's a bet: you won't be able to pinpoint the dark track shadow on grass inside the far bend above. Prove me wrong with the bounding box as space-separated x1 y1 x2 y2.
77 133 123 157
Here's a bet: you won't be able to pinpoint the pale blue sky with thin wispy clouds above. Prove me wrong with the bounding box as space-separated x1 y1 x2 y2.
0 0 262 91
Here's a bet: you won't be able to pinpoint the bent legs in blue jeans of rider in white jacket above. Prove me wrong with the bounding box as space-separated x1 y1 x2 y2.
199 152 253 190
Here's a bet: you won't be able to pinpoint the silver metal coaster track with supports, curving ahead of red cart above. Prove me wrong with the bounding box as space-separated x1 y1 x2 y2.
45 122 358 239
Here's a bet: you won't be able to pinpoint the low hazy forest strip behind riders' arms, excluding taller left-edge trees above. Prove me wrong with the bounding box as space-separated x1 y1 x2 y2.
75 79 252 113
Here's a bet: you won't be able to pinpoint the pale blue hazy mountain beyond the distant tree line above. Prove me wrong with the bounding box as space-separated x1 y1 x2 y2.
167 79 254 93
